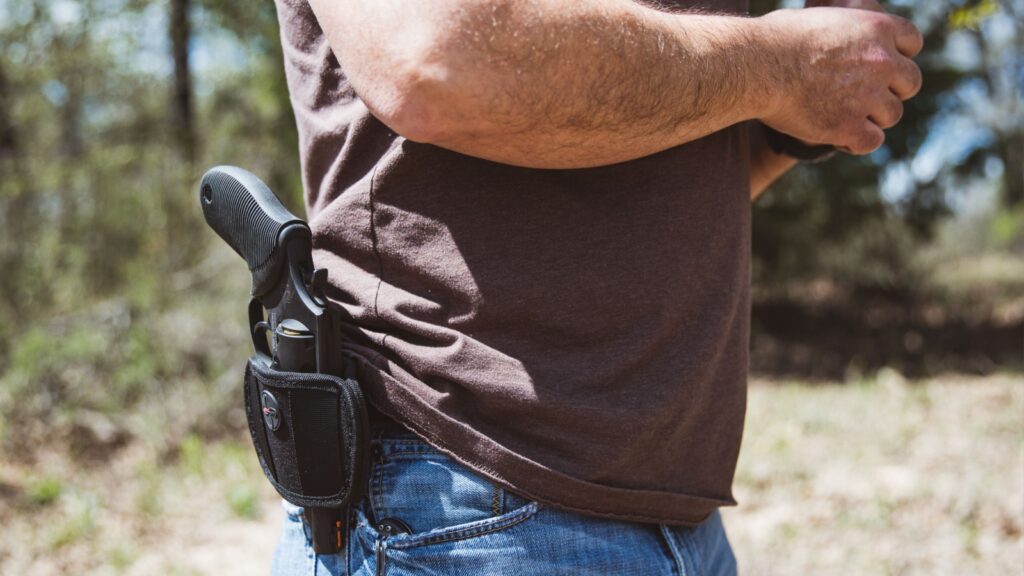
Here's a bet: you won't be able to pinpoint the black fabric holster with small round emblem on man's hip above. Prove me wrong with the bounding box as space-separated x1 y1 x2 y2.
239 357 369 553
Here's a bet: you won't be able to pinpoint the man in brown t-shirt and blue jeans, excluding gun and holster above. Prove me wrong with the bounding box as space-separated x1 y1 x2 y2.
264 0 922 575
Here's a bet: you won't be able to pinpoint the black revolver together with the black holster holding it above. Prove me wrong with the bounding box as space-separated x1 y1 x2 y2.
199 166 369 553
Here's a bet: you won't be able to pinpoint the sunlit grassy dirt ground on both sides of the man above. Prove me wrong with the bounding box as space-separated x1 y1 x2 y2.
0 372 1024 576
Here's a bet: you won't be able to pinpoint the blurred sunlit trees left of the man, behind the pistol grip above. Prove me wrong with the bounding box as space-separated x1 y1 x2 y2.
0 0 299 379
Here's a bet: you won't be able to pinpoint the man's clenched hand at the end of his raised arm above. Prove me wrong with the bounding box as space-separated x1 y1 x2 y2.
761 7 924 155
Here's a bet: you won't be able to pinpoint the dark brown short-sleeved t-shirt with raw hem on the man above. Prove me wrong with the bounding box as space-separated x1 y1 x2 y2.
276 0 751 524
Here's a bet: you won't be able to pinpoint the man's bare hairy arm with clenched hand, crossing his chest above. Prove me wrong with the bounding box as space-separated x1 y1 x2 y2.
310 0 921 168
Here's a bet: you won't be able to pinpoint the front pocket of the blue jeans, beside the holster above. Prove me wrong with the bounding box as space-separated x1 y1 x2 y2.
369 438 539 548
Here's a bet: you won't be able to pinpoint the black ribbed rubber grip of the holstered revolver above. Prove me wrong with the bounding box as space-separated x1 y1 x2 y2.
199 166 309 297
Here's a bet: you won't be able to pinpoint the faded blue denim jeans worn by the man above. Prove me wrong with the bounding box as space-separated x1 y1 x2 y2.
271 428 736 576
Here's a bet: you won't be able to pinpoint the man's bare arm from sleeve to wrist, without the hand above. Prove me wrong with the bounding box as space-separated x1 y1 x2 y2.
312 0 784 168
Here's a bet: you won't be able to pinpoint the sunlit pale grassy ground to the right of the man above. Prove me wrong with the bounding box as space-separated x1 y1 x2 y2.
725 373 1024 575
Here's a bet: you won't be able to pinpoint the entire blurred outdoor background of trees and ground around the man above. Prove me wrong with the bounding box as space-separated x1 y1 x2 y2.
0 0 1024 575
